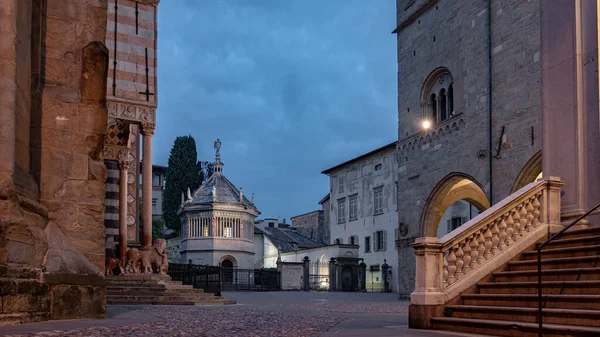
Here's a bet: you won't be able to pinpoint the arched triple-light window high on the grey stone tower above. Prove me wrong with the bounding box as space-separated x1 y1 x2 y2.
421 68 454 124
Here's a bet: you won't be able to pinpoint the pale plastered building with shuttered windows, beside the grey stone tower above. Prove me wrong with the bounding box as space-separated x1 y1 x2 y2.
322 142 398 292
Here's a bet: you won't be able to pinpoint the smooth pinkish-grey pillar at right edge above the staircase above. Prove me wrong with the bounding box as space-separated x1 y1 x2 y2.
540 0 600 223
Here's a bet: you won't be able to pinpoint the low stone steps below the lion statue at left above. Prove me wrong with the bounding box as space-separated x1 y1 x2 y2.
106 274 235 305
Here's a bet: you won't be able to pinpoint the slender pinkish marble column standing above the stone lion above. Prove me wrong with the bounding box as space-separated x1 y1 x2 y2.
142 123 154 248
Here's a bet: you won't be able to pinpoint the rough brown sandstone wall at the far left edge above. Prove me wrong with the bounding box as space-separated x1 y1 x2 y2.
0 0 109 325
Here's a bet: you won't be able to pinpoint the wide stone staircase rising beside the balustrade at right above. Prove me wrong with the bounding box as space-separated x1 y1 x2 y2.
431 228 600 337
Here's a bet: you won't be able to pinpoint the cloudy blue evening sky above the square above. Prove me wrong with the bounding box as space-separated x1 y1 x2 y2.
153 0 398 219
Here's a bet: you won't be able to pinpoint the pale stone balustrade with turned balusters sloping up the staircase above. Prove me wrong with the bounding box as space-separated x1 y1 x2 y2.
411 177 563 306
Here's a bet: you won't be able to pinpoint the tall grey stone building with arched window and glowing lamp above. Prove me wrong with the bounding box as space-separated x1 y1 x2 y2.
394 0 542 296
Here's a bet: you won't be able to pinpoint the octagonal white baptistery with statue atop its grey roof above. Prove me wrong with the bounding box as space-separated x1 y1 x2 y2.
177 141 260 268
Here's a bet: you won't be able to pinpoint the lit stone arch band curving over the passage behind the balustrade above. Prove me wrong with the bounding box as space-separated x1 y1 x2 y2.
420 172 490 237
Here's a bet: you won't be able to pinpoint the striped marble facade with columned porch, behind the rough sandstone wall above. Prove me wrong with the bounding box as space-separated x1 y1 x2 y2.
104 0 159 258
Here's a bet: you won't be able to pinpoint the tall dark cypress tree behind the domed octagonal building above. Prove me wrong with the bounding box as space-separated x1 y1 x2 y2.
162 135 204 233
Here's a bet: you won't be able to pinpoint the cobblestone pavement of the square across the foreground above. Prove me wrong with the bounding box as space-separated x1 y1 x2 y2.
0 292 488 337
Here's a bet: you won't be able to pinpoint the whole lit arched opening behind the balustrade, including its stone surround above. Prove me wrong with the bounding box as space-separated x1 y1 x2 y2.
421 173 490 237
